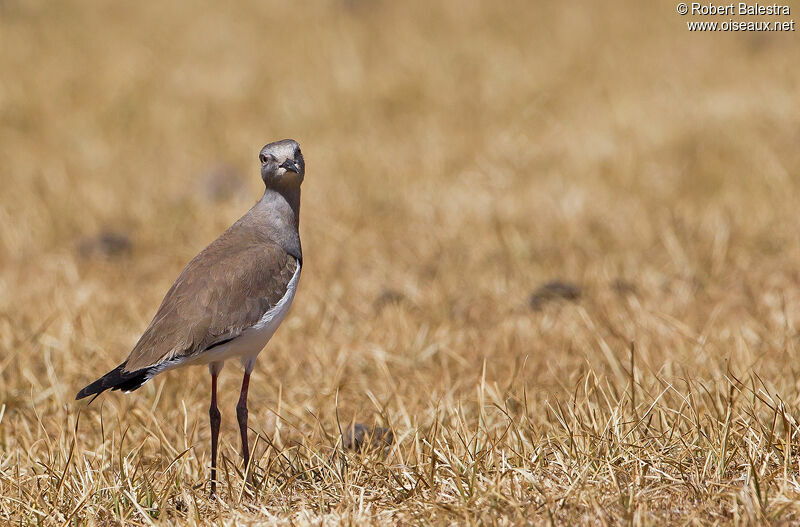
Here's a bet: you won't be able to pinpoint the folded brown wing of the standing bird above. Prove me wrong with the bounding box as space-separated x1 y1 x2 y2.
124 229 299 371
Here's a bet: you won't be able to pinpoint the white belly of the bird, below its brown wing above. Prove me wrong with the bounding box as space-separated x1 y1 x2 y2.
184 265 300 373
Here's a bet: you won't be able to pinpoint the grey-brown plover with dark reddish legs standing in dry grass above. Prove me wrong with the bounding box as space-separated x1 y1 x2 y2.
76 139 305 496
